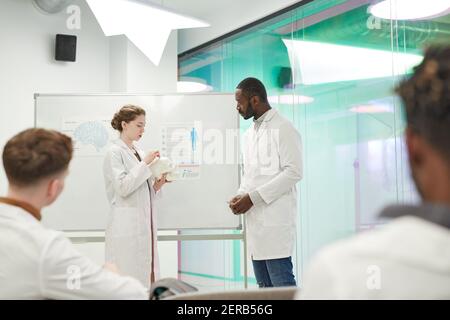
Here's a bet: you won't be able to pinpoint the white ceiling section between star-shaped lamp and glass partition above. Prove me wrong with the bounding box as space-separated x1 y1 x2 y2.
153 0 300 53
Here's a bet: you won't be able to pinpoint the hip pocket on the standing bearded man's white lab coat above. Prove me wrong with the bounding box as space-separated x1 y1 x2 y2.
263 196 295 227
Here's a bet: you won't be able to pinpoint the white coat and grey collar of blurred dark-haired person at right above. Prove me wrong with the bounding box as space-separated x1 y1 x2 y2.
296 203 450 299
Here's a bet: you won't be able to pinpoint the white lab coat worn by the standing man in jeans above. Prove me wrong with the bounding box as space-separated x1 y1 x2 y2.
238 109 302 260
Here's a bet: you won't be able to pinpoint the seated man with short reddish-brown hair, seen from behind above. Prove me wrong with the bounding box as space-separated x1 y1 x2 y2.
0 129 148 299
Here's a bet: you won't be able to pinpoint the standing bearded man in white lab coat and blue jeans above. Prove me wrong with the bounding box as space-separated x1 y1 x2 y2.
230 78 302 287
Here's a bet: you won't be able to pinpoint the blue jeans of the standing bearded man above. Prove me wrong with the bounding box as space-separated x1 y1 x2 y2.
252 257 296 288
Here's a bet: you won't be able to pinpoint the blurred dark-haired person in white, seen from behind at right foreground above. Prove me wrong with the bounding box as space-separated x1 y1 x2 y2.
298 46 450 299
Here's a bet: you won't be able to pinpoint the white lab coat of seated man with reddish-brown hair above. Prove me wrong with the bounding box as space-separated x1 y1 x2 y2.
0 203 148 299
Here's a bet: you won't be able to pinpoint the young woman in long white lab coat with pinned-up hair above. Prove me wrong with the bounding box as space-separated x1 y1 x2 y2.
103 105 167 287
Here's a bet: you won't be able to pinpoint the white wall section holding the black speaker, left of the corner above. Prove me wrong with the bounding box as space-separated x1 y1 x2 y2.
0 0 109 194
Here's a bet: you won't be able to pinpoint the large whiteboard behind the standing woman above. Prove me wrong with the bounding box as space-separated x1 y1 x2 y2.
35 94 241 231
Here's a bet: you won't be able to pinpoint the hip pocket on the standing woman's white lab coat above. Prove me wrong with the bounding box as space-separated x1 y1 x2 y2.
111 207 139 237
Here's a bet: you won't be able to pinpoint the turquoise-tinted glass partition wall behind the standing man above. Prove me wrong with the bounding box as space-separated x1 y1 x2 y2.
179 0 450 288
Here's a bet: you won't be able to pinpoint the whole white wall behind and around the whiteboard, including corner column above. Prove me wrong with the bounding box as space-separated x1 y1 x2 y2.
0 0 177 277
